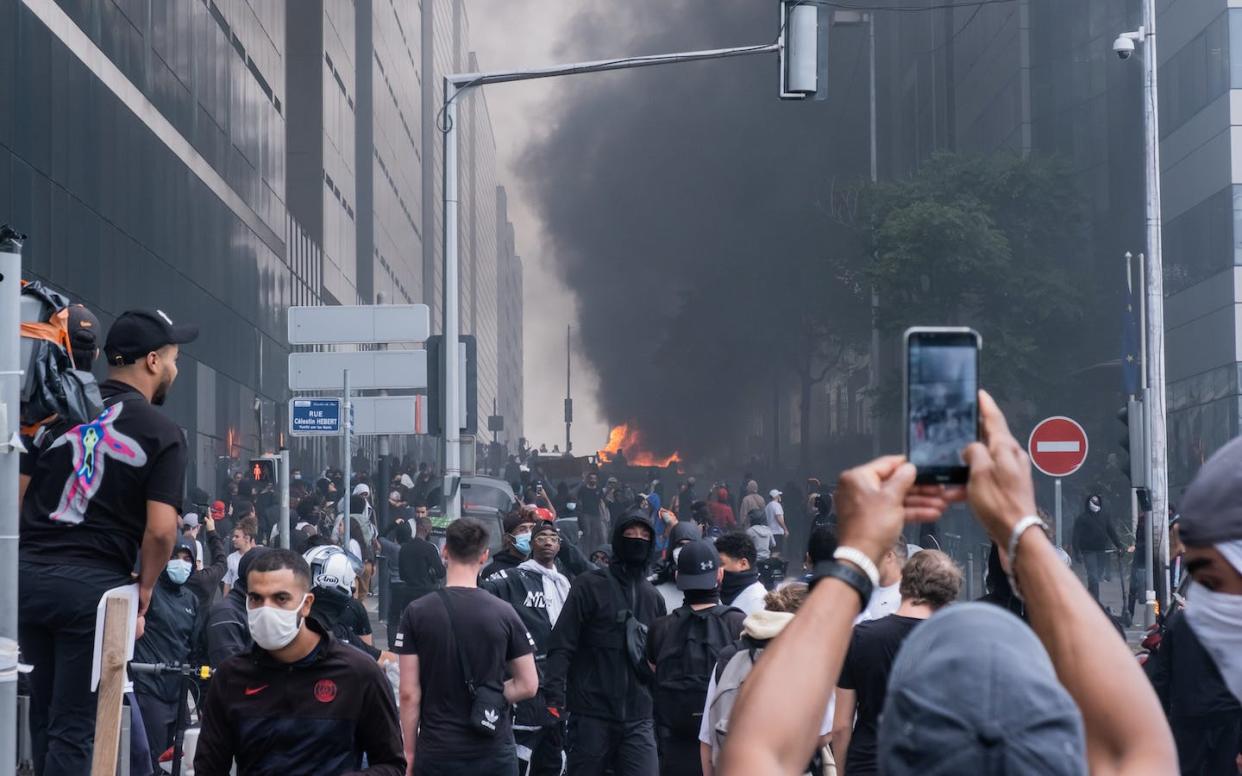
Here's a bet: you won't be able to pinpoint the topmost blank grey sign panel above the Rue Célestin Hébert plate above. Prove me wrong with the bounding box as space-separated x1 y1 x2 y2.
289 304 431 345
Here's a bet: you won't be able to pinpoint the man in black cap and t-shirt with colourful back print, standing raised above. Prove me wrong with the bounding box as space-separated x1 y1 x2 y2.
17 310 197 776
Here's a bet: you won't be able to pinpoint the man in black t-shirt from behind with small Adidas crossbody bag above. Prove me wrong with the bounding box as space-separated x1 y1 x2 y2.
392 518 539 776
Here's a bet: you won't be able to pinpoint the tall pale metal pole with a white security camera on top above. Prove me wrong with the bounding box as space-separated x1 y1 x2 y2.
1113 0 1169 618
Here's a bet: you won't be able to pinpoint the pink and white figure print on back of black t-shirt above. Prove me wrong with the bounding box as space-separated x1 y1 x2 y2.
48 402 147 525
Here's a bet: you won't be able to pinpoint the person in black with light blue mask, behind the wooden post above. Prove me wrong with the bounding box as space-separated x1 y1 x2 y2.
133 541 200 774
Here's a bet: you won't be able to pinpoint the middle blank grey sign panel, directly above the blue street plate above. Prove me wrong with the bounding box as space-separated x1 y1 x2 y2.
289 350 427 391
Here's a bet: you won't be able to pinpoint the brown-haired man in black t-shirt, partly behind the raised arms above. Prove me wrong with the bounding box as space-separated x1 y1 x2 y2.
832 550 961 776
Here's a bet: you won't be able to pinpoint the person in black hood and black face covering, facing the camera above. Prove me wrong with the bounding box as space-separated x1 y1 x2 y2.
544 510 667 776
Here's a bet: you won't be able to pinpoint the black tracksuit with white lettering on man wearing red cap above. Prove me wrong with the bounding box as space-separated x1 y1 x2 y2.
479 556 563 776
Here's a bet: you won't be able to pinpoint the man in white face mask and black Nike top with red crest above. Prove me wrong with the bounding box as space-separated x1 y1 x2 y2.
194 550 406 776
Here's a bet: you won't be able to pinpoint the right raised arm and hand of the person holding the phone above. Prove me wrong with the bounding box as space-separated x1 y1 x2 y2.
966 391 1177 776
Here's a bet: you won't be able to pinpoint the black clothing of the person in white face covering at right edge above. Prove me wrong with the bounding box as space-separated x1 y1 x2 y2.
1145 610 1242 776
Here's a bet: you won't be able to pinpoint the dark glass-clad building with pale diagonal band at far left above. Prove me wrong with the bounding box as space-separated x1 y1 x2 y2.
0 0 290 492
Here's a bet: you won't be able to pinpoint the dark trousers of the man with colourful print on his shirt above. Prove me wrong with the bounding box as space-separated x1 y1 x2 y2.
17 562 130 776
